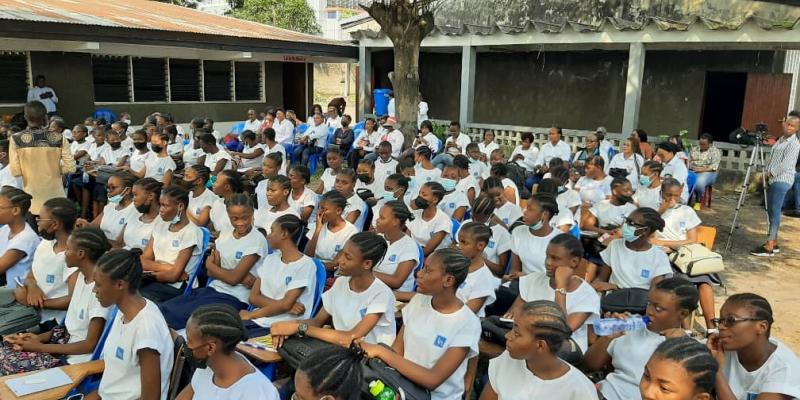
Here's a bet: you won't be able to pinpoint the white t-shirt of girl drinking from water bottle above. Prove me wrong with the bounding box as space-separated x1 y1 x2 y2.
600 329 665 400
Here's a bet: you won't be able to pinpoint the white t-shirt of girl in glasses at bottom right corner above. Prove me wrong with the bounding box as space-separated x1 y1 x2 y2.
720 338 800 400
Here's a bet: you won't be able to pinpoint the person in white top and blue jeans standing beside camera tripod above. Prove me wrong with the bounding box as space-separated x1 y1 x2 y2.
750 116 800 257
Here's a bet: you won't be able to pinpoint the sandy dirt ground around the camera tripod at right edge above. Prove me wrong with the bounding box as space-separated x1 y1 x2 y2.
699 191 800 353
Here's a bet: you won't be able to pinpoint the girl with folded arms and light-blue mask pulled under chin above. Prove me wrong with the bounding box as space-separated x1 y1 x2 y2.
139 185 204 303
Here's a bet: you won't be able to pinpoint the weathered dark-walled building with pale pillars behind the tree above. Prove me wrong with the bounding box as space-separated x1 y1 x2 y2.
343 0 800 150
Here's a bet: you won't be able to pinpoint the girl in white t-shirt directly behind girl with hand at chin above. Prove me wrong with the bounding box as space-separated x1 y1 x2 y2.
510 193 562 280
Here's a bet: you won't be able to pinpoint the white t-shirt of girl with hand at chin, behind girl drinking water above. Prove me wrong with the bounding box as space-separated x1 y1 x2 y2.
519 272 600 353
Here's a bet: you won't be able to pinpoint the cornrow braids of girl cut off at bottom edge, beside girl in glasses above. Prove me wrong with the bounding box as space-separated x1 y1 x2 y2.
651 336 719 394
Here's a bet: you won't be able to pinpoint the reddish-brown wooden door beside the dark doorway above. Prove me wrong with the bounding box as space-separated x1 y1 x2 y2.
742 73 792 136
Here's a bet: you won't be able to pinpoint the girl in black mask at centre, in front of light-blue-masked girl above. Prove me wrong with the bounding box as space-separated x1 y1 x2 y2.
406 182 453 256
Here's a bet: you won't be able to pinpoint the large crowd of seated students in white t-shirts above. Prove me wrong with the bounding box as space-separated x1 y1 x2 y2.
0 108 800 400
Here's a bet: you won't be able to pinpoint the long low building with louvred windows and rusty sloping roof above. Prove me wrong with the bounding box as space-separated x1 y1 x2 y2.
0 0 358 123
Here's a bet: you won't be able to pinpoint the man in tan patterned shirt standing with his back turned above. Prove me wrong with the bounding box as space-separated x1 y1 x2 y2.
8 101 75 215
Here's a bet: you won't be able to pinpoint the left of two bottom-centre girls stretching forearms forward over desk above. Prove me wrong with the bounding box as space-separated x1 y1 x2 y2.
270 232 396 348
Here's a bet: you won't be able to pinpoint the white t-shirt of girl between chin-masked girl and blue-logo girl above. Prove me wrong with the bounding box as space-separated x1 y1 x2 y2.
208 229 269 303
